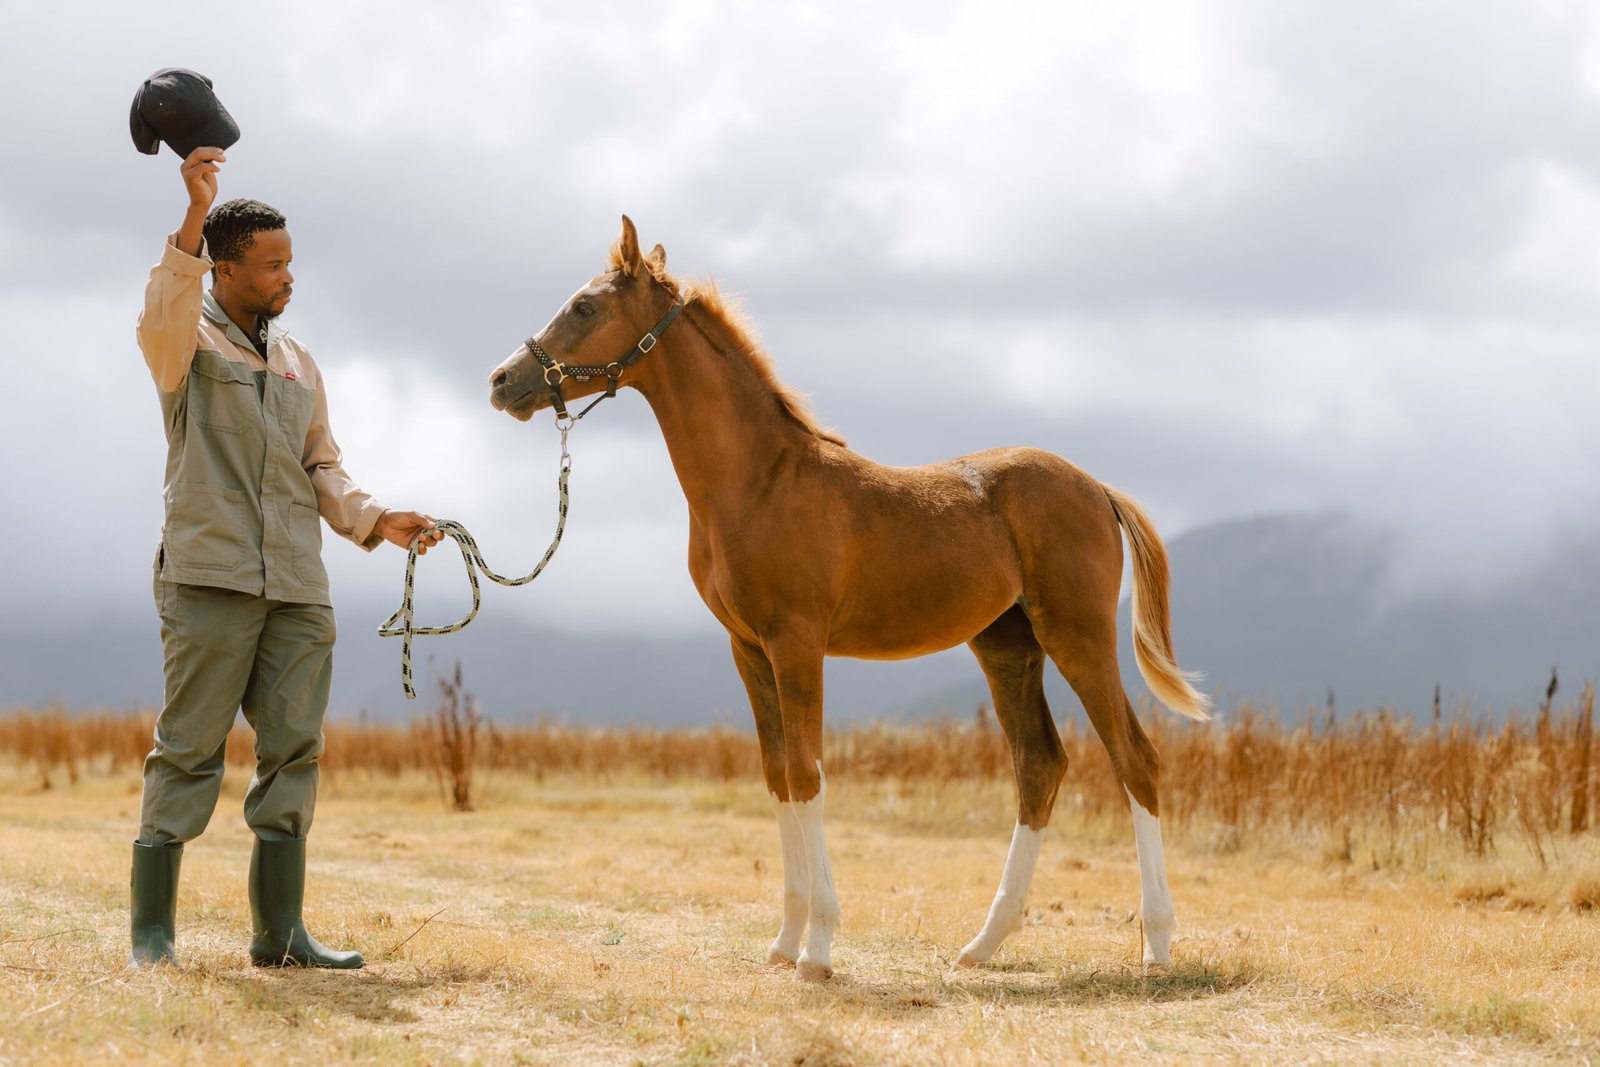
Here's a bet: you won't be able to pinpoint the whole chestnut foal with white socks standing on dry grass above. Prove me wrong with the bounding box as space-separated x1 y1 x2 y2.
490 216 1208 981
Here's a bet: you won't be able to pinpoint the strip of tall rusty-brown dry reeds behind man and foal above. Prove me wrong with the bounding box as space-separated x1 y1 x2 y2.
0 685 1595 862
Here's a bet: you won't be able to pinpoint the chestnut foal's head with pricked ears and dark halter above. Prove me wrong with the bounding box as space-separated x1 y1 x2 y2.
490 214 678 422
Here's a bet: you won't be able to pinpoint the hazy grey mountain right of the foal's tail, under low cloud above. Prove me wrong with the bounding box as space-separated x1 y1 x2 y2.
1171 515 1600 713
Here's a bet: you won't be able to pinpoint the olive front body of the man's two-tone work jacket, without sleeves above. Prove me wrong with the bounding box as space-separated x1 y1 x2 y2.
160 293 331 606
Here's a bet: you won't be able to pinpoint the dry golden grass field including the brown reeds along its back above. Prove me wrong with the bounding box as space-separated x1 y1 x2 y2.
0 697 1600 1065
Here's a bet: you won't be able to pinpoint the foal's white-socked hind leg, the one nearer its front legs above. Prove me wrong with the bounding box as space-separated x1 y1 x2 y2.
957 608 1067 966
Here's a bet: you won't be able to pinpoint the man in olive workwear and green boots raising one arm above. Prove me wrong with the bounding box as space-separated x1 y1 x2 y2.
131 147 440 968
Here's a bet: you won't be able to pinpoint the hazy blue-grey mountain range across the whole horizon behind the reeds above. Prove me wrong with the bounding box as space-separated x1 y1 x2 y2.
0 514 1600 726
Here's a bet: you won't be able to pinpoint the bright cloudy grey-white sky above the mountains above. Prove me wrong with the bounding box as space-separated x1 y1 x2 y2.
0 0 1600 675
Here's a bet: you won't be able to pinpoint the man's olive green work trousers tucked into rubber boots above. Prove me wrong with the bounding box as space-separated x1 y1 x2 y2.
139 579 334 845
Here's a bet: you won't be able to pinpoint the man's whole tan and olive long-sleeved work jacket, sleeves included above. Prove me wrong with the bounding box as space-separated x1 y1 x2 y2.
138 237 384 605
